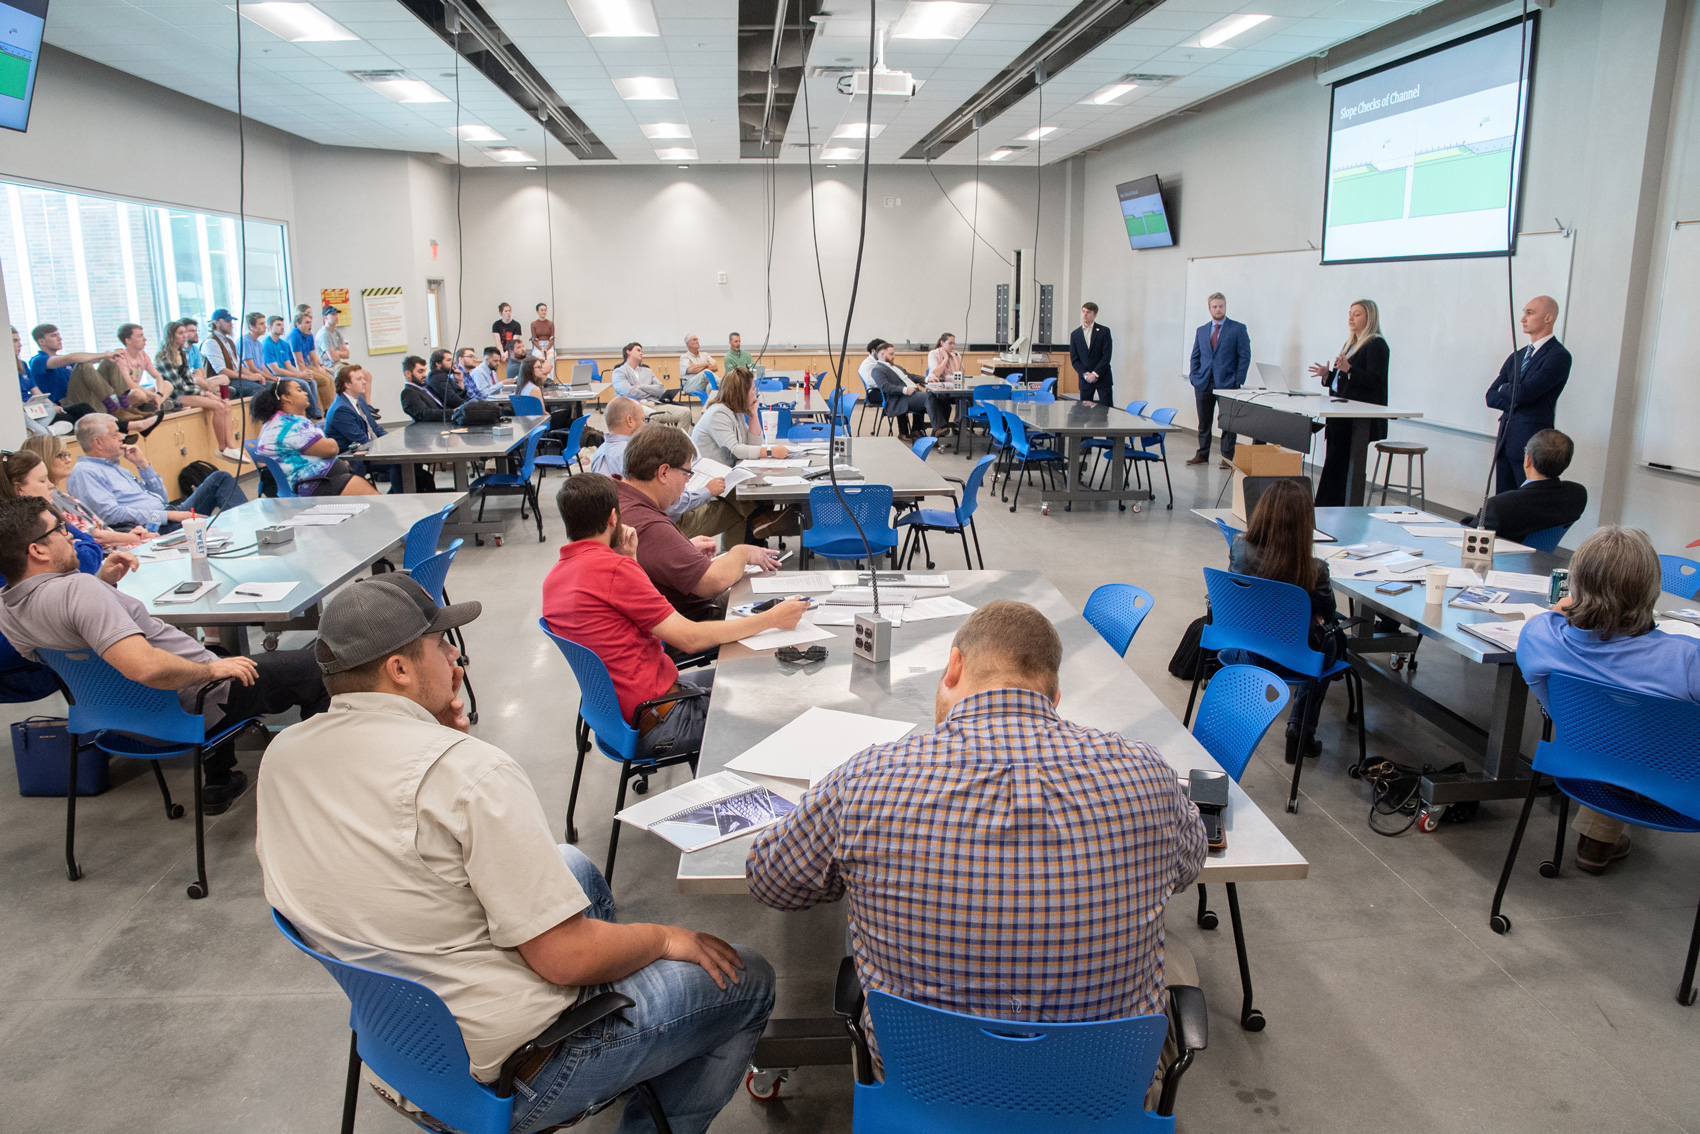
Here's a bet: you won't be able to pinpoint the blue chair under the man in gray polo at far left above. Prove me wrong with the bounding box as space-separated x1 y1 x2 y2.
36 649 255 898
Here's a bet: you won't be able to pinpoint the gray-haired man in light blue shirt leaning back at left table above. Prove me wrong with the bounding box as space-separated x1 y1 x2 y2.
66 413 248 532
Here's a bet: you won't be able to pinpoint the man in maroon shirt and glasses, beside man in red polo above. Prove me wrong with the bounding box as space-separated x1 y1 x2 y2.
619 425 779 621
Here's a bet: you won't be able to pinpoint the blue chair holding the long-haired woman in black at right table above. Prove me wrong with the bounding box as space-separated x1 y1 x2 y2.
1187 568 1367 811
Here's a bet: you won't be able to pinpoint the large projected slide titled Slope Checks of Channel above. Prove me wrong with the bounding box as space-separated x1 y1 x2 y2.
1323 22 1533 264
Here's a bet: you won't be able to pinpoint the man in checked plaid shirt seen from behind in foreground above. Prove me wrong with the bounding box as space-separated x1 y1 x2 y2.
745 602 1205 1047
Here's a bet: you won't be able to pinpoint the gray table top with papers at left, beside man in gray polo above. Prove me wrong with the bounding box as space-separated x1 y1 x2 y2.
119 493 466 626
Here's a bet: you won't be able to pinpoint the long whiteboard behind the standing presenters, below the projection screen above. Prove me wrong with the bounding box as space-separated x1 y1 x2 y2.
1182 230 1576 437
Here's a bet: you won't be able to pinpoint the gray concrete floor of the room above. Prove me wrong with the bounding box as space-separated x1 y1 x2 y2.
0 445 1700 1134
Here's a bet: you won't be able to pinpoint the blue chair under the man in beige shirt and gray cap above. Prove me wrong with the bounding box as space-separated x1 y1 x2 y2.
272 910 668 1134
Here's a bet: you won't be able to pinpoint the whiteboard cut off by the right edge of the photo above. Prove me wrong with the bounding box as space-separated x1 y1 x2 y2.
1641 224 1700 476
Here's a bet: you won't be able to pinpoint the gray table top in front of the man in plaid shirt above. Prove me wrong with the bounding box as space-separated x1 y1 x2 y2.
678 571 1309 894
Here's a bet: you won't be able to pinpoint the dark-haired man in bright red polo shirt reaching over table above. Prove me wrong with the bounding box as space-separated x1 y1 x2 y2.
542 473 808 755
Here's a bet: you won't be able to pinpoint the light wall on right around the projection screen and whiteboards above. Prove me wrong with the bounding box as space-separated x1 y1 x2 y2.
1081 0 1700 546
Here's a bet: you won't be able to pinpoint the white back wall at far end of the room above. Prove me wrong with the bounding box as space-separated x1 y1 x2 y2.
462 165 1074 368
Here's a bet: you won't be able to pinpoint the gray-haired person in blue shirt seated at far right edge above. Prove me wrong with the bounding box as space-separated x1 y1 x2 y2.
1516 525 1700 874
